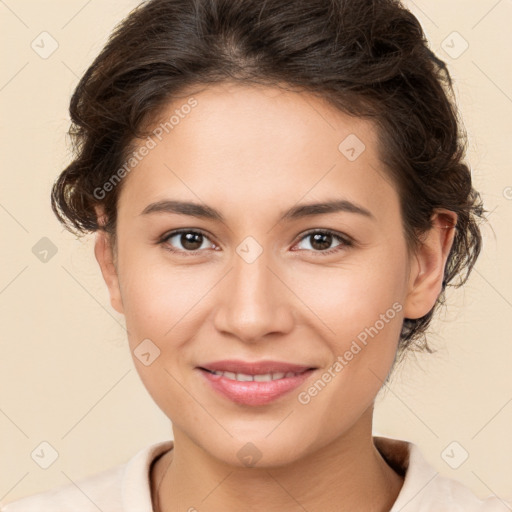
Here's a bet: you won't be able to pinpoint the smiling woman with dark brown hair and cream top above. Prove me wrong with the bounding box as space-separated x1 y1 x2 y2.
2 0 509 512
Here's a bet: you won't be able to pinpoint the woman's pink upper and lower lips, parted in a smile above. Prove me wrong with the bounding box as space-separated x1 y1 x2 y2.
196 360 316 406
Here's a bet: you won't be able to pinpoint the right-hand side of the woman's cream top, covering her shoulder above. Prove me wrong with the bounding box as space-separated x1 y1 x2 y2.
373 436 512 512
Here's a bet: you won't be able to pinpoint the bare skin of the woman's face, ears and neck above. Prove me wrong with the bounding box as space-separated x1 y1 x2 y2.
95 83 456 512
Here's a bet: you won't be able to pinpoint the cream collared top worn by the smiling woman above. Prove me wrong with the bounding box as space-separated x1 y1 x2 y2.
0 436 512 512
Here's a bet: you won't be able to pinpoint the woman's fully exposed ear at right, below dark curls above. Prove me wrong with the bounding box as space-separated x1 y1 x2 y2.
404 209 457 319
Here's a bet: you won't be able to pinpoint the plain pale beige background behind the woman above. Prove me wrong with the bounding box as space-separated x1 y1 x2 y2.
0 0 512 502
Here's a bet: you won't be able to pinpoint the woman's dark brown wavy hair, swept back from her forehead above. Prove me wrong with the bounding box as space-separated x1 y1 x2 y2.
51 0 485 360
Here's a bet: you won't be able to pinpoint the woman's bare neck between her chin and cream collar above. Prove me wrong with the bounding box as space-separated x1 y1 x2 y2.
152 411 403 512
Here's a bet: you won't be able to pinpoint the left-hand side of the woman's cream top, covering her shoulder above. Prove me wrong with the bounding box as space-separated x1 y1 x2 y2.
0 441 172 512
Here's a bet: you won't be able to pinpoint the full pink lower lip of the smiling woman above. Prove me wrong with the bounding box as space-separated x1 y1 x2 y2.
199 368 314 405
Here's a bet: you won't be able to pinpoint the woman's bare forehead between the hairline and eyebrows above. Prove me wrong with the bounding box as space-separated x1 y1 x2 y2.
119 83 397 220
